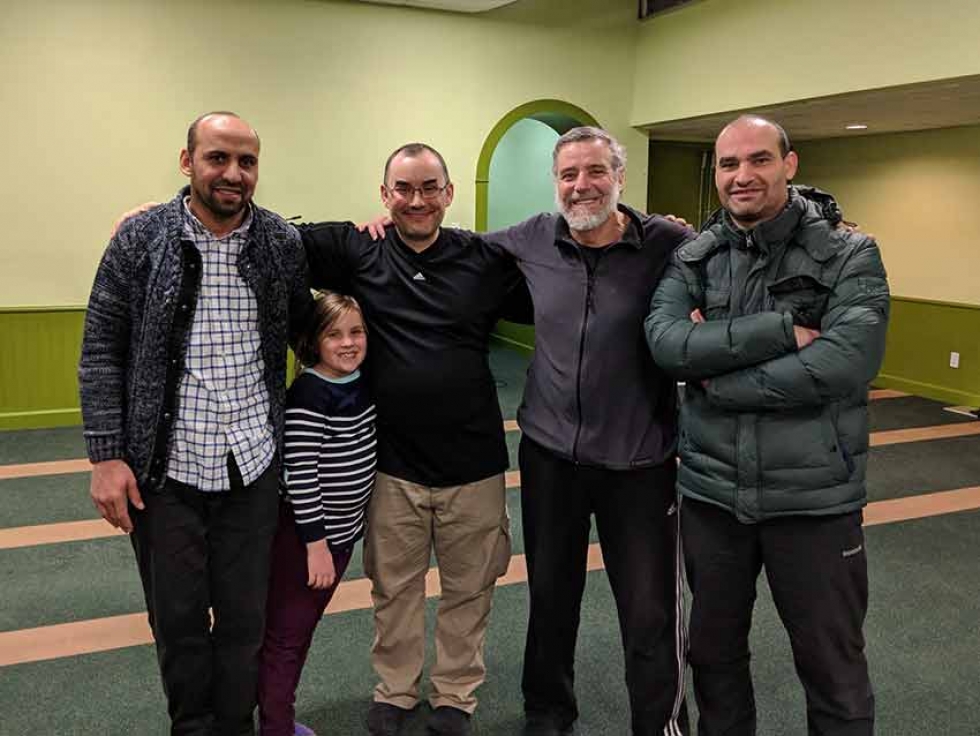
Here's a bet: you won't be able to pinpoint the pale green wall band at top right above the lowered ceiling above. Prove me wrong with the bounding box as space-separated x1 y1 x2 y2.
630 0 980 125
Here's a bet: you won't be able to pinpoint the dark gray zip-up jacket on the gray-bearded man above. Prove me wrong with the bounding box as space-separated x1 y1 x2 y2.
487 205 692 470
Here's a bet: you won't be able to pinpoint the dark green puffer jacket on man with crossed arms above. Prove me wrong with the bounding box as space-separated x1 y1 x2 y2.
645 187 889 523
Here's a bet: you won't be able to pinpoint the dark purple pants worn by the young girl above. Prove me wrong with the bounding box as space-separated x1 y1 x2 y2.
258 500 352 736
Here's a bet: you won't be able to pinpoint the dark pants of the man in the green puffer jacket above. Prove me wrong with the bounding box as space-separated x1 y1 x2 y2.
681 499 874 736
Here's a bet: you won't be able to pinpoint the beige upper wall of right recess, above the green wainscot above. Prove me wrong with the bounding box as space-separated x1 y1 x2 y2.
797 126 980 304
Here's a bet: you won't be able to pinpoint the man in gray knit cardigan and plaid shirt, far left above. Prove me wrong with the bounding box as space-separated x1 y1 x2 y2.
79 112 311 734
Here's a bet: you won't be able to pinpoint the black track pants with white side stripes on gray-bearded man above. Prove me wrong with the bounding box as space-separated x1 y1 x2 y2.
520 437 687 736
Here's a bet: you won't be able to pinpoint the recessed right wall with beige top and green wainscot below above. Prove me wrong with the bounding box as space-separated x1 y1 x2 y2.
797 126 980 406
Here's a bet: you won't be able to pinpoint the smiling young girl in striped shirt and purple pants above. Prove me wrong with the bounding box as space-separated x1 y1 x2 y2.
258 292 376 736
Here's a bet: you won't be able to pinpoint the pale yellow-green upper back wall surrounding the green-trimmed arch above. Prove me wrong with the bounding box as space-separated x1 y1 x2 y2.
0 0 647 306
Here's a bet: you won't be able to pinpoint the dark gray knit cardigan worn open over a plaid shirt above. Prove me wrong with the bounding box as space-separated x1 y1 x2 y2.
78 188 312 491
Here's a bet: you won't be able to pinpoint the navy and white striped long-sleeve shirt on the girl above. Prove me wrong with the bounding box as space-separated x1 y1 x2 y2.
284 369 377 548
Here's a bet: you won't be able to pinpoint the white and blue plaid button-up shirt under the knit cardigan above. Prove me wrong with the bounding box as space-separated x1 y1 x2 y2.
167 198 276 491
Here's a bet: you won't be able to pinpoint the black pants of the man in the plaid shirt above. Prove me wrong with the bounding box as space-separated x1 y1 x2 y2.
130 456 279 736
